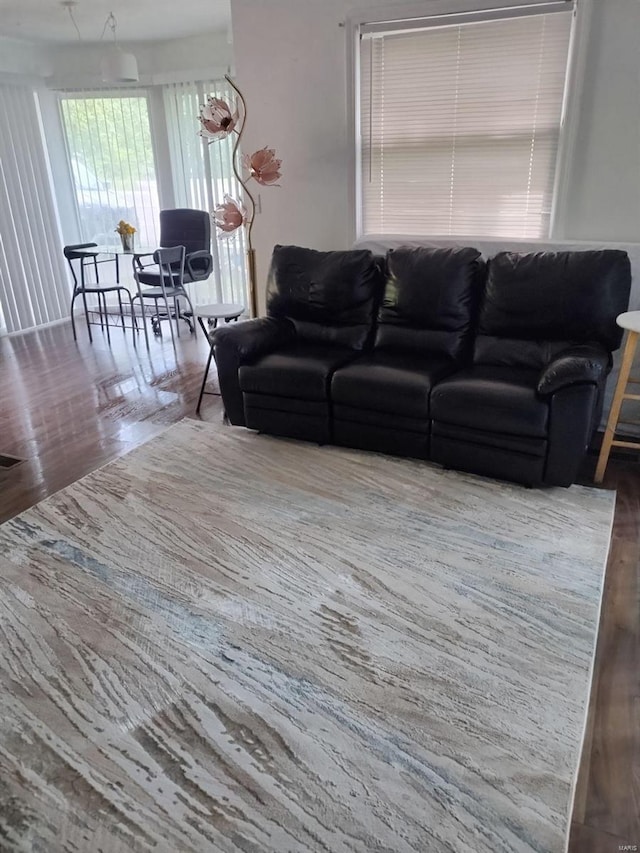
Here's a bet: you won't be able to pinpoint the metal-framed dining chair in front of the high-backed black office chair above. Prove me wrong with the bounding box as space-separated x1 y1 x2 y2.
133 246 195 347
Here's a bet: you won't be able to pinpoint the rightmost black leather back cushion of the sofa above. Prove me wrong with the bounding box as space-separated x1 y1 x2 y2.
474 249 631 368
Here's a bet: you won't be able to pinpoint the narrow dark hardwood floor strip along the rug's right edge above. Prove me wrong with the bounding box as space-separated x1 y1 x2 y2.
569 460 640 853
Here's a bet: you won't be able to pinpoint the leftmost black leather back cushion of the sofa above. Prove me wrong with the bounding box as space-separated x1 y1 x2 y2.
267 246 384 350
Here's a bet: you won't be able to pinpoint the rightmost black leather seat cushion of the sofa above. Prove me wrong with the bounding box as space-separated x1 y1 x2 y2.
431 365 549 438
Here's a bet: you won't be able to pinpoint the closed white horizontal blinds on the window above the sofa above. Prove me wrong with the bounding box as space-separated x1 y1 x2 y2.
360 6 572 238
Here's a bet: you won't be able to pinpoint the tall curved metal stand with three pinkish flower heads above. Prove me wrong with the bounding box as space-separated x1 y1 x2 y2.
199 75 282 317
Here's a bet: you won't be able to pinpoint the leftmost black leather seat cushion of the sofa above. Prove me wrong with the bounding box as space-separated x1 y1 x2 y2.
239 344 357 400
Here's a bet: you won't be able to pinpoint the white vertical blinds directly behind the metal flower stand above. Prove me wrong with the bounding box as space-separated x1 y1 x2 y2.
163 80 247 304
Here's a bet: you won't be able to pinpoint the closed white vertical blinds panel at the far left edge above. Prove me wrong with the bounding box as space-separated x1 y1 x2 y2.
0 85 70 332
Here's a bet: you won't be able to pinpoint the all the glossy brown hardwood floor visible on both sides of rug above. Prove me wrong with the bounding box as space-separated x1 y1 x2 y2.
0 324 640 853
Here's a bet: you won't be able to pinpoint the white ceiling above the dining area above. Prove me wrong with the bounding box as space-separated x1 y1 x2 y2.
0 0 231 44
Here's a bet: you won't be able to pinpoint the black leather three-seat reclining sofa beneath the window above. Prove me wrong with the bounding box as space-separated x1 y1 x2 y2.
212 246 631 486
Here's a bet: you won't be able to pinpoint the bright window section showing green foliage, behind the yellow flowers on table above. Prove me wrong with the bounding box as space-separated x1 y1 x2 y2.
61 92 160 246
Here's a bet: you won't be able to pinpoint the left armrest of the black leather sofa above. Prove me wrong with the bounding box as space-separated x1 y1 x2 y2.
210 317 296 426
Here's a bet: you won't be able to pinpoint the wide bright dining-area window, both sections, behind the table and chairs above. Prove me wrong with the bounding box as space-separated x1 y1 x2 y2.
60 80 246 304
